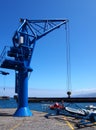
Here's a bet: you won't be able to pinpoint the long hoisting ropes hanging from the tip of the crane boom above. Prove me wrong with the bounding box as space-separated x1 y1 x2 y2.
65 23 72 91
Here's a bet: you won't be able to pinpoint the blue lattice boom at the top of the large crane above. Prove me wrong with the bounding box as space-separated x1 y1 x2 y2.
13 19 68 45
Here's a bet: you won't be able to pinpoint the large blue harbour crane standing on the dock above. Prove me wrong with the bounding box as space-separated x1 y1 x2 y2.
0 19 68 117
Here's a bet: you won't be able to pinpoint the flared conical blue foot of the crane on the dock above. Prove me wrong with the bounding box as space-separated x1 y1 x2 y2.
14 107 33 117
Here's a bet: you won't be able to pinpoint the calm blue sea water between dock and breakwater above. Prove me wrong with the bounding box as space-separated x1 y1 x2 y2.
0 98 96 111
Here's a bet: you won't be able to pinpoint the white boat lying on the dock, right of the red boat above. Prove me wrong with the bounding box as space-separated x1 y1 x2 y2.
65 107 86 116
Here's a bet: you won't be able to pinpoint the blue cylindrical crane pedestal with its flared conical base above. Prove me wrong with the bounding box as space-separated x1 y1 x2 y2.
14 69 32 117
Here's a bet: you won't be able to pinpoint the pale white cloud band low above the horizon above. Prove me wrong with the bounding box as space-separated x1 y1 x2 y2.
0 87 96 97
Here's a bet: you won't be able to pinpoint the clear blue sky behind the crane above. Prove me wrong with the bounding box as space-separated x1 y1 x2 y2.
0 0 96 97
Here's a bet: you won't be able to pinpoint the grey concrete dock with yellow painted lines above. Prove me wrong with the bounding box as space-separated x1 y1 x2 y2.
0 109 96 130
